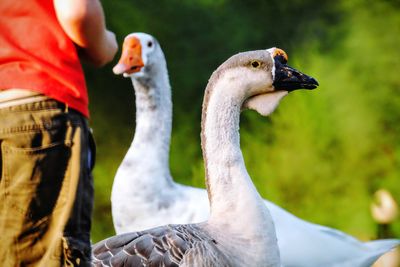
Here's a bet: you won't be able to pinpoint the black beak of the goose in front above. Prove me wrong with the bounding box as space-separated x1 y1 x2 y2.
273 55 319 92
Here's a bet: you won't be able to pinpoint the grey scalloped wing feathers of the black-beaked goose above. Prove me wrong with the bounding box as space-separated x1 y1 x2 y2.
92 224 216 267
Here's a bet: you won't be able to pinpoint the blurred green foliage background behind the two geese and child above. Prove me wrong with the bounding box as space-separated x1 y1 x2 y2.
85 0 400 242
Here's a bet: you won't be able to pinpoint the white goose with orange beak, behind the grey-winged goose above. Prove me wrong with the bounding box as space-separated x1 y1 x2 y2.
107 33 399 267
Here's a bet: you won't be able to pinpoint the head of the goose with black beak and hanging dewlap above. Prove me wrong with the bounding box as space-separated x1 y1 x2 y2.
209 47 319 116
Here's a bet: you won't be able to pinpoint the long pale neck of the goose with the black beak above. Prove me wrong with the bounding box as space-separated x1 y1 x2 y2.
201 70 276 247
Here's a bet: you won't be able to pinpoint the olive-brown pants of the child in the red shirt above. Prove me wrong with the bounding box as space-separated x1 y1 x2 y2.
0 99 94 267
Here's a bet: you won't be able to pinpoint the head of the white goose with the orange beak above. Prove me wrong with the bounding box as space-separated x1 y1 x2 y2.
113 33 166 79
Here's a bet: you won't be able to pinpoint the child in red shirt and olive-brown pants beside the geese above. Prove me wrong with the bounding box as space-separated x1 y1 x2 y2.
0 0 118 267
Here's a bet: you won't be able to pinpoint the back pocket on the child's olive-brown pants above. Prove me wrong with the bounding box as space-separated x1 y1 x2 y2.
3 140 70 220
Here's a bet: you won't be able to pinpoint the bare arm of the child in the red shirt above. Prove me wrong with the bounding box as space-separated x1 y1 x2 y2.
54 0 118 67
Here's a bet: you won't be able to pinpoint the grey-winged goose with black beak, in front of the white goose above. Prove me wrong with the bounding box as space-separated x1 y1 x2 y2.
93 45 318 267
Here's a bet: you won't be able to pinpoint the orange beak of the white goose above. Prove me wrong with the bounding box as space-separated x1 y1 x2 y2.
113 37 144 75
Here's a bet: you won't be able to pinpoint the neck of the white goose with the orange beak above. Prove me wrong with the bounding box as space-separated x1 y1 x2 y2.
125 66 172 183
